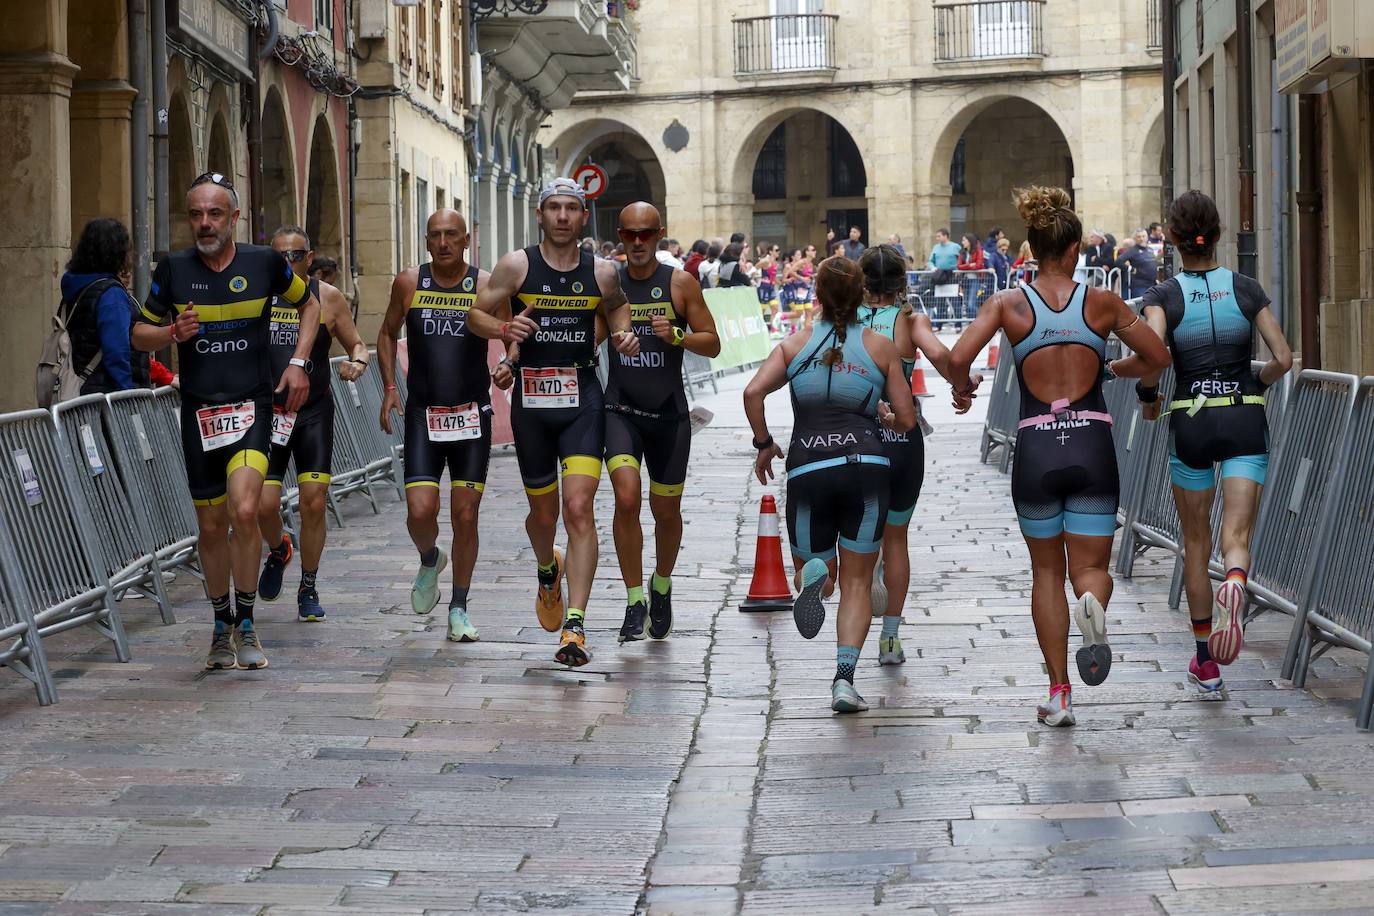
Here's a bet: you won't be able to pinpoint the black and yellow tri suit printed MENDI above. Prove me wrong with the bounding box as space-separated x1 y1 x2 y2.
606 264 691 496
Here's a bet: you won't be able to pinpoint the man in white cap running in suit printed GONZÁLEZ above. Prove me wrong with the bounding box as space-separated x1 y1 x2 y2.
473 179 639 667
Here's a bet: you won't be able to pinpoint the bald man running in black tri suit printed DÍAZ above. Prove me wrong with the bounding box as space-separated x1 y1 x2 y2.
376 210 500 643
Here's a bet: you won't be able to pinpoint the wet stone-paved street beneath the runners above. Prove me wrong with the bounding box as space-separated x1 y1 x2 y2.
0 374 1374 916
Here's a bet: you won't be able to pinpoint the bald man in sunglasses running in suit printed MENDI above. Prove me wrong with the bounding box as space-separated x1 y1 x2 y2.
606 202 720 643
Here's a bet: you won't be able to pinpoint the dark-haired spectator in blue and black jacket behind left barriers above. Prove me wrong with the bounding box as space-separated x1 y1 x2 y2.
62 218 150 394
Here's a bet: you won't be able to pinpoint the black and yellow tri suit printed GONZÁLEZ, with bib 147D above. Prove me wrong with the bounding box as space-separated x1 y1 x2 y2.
511 244 606 496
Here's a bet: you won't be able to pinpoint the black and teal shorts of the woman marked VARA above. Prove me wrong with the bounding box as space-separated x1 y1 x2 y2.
787 455 890 560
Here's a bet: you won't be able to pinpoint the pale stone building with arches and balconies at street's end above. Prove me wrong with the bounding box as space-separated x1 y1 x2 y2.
545 0 1164 254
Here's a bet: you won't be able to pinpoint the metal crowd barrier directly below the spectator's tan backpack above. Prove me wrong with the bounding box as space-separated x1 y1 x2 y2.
52 394 176 623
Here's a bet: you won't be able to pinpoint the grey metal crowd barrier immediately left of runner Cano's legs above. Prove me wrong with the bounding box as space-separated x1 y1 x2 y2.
106 387 202 578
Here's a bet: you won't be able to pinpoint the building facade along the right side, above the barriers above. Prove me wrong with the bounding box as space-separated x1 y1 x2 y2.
1168 0 1374 375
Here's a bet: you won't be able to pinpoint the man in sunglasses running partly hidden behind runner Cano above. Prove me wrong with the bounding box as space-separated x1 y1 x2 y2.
258 225 367 622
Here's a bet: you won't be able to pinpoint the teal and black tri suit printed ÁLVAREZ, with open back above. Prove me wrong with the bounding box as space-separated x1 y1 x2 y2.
1011 283 1120 538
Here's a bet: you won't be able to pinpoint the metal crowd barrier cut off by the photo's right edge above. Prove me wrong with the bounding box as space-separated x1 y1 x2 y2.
1283 376 1374 728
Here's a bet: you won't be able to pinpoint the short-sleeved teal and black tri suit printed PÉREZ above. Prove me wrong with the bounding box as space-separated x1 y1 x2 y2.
1142 268 1270 490
